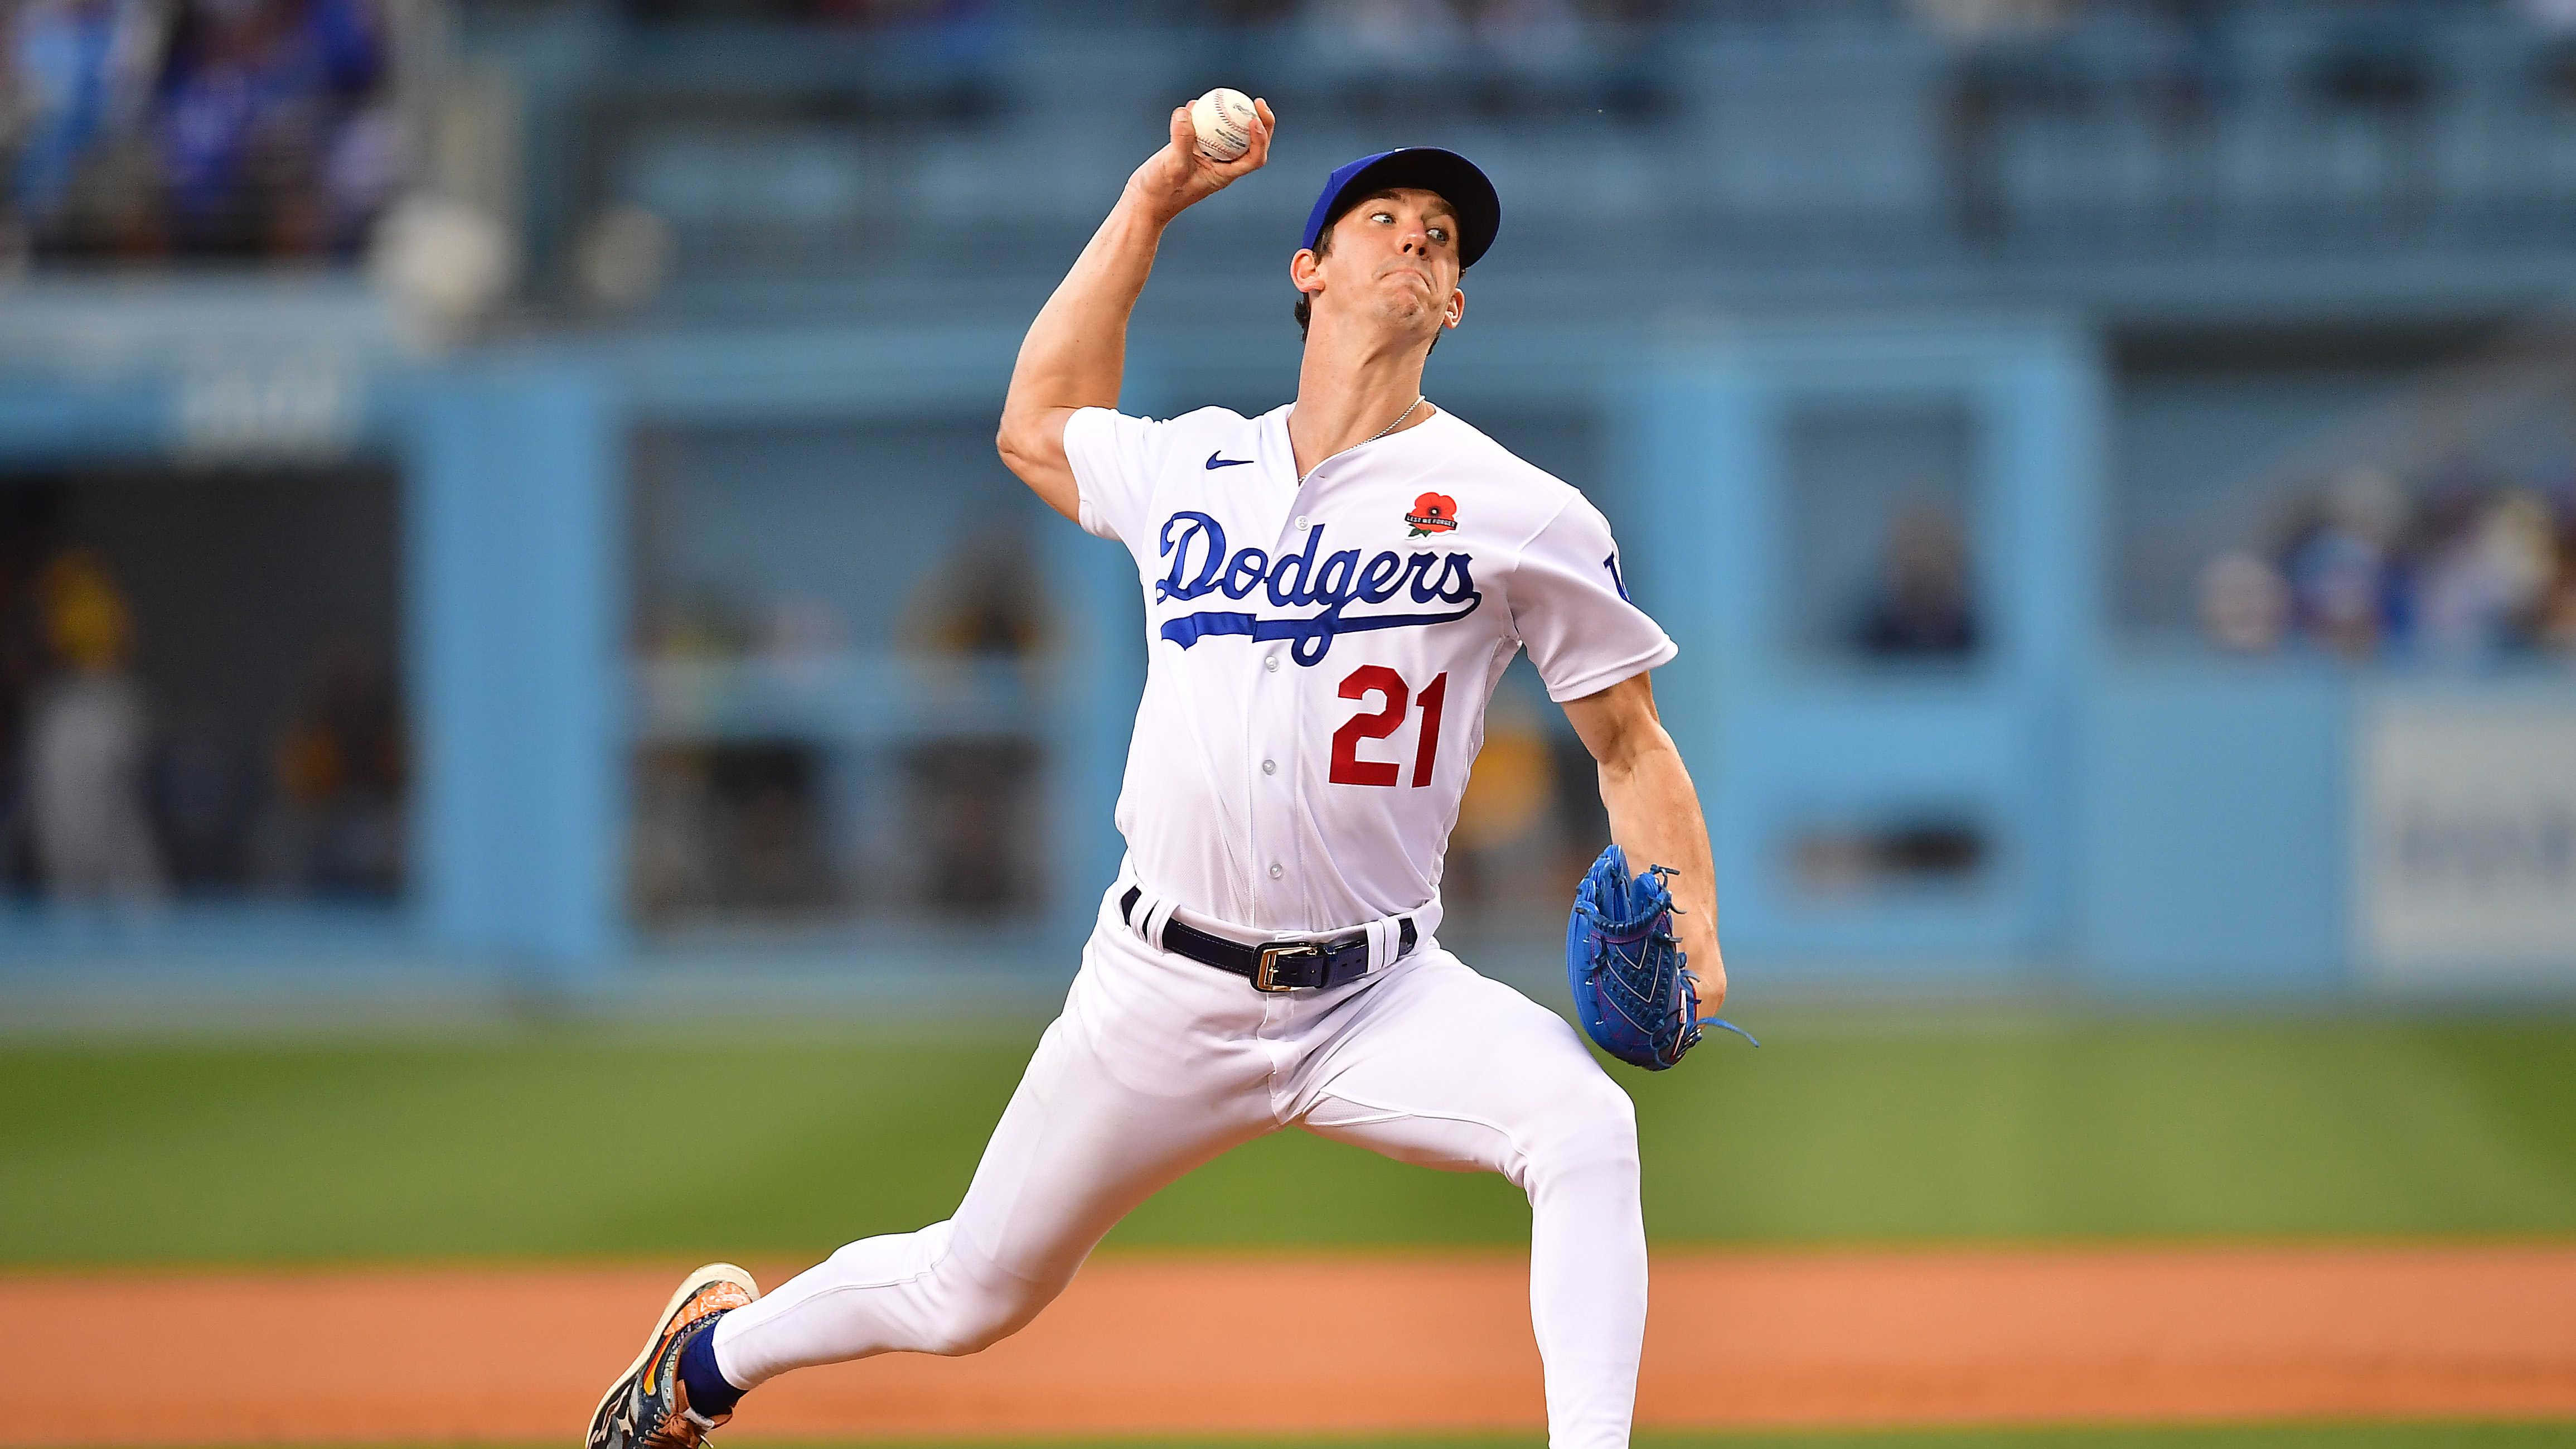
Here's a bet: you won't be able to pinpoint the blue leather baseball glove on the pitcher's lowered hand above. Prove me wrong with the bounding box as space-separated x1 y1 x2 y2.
1566 846 1762 1073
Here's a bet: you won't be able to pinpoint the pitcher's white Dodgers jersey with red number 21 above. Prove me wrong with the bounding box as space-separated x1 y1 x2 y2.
1064 407 1674 933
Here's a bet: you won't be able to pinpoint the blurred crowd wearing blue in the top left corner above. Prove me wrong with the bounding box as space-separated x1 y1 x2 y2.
8 0 402 258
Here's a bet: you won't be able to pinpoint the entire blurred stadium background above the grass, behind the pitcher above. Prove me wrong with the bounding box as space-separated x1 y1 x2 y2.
0 0 2576 998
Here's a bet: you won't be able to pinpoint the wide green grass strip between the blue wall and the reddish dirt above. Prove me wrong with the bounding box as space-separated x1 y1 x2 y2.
0 1008 2576 1263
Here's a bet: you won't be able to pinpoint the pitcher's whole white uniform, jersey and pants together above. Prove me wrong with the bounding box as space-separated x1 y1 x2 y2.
714 407 1672 1449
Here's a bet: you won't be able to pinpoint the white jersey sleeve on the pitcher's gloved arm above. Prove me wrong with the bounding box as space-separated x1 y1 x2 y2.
1512 498 1679 704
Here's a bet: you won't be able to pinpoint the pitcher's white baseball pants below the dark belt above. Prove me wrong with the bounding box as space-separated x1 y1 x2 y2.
716 900 1646 1449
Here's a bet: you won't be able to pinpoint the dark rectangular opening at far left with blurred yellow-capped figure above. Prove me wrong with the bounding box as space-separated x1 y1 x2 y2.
0 459 410 915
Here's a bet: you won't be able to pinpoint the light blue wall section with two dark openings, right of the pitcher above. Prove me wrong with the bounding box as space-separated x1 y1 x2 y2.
1630 320 2102 974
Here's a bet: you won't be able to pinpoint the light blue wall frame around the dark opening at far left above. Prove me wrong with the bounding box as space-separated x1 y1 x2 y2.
0 361 623 980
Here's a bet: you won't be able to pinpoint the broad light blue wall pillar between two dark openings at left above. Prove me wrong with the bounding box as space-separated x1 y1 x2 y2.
404 361 626 977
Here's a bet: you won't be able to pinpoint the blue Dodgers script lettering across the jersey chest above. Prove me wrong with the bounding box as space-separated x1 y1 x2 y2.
1154 513 1484 665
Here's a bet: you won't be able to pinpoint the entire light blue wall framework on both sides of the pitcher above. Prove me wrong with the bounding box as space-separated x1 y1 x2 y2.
0 317 2576 995
